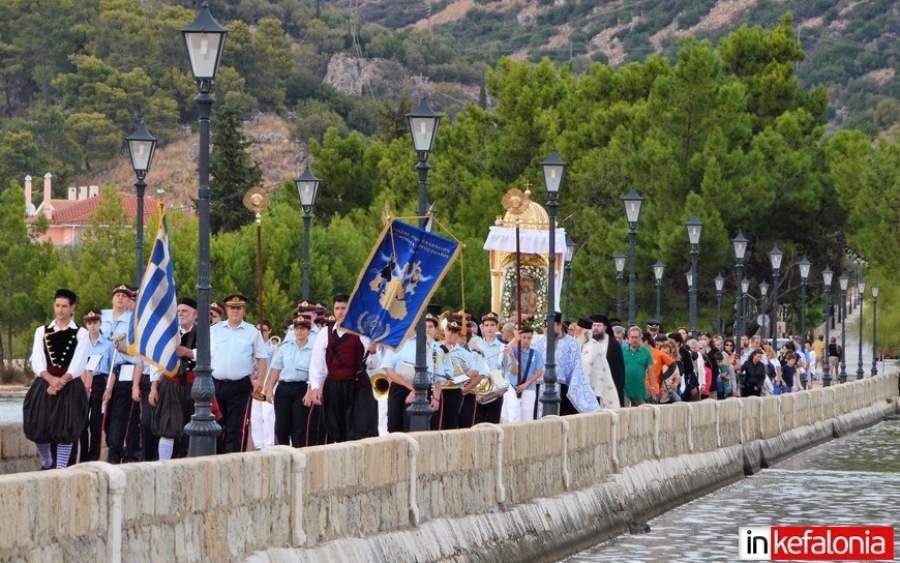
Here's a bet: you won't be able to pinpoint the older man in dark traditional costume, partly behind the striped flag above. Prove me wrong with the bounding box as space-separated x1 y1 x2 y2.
150 297 197 459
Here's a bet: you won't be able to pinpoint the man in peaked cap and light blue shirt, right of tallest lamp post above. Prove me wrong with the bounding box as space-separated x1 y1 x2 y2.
209 294 269 453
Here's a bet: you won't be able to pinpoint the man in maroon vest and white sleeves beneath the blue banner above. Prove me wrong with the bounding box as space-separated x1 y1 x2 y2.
308 294 378 443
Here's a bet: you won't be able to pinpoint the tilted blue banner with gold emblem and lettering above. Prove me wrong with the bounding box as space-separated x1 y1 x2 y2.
341 220 459 349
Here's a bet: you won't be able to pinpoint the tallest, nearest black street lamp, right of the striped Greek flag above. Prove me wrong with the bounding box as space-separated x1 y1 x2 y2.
181 2 228 456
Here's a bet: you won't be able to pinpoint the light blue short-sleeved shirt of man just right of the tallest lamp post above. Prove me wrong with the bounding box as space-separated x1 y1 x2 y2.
209 321 269 380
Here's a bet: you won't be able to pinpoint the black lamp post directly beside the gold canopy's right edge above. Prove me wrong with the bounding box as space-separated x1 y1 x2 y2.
541 149 566 416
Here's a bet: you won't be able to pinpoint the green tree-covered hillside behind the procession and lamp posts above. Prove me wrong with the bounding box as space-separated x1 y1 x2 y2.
0 0 900 366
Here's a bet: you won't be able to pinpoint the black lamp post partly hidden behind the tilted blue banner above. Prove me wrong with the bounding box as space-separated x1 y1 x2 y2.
406 97 441 432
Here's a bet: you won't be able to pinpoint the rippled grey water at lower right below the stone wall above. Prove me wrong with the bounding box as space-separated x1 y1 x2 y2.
564 421 900 563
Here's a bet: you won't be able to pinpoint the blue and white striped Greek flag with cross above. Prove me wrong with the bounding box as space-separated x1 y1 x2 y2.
128 206 180 375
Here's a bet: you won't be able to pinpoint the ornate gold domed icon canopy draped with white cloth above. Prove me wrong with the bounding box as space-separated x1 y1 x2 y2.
484 188 566 319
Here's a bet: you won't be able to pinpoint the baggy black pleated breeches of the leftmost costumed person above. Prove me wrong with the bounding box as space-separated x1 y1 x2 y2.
22 377 88 444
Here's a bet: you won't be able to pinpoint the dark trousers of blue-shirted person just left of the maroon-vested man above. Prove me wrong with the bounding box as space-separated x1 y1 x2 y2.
274 381 322 448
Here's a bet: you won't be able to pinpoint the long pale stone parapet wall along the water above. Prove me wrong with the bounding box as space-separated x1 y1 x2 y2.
0 374 898 563
